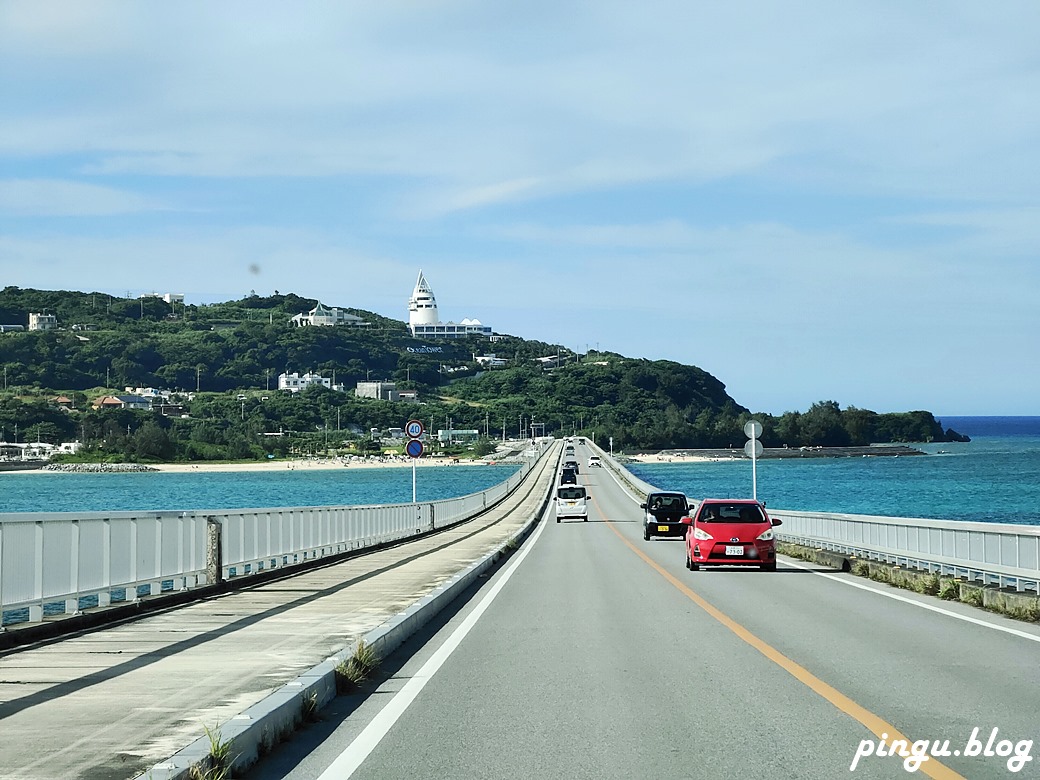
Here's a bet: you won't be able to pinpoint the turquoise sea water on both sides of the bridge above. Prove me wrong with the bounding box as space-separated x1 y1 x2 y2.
0 417 1040 524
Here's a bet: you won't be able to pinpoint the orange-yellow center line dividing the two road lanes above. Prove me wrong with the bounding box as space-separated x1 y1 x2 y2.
593 499 965 780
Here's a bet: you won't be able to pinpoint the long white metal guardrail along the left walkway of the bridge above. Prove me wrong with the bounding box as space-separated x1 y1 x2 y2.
0 447 548 630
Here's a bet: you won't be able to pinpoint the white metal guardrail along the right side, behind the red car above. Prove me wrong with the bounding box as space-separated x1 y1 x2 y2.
602 445 1040 595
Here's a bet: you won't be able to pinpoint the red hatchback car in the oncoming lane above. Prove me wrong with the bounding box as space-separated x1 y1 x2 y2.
682 498 780 571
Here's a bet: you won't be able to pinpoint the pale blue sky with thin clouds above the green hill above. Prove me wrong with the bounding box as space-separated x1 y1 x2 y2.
0 0 1040 416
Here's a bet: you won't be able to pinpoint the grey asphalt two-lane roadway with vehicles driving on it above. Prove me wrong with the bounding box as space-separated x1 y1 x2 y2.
249 449 1040 780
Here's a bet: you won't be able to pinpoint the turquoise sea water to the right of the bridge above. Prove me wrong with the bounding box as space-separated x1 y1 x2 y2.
629 417 1040 525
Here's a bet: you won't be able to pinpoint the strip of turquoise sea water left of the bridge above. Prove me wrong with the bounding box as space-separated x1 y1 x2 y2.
0 464 517 513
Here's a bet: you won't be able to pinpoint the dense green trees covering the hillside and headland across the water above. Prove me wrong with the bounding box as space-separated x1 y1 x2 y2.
0 287 956 461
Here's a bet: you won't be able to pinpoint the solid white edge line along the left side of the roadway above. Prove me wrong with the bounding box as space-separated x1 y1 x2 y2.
318 509 547 780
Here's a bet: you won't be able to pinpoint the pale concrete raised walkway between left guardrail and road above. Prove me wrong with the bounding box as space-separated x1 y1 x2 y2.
0 445 560 780
